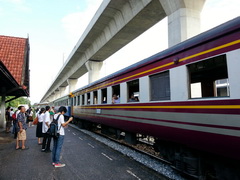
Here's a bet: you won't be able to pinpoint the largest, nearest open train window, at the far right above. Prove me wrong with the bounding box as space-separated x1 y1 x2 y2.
188 55 230 98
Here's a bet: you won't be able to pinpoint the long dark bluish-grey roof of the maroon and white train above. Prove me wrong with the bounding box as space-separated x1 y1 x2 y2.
73 16 240 93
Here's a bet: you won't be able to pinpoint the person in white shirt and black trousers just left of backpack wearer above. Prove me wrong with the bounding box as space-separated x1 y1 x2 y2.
42 106 51 152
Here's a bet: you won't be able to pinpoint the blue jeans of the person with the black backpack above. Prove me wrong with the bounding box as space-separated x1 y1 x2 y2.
52 135 64 164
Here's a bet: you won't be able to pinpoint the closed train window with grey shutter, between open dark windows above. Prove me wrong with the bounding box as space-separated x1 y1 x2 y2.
150 71 170 101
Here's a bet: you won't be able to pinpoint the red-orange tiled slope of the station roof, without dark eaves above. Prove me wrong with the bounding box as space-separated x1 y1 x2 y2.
0 36 28 85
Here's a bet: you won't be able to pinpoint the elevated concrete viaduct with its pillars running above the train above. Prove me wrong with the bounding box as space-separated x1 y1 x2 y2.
41 0 205 102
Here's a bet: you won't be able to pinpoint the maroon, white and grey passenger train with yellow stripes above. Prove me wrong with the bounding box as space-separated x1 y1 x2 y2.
53 17 240 180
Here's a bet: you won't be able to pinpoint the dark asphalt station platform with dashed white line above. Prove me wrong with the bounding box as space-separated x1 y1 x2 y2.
0 126 162 180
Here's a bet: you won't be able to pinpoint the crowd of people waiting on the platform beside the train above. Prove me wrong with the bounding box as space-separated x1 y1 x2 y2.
5 106 73 167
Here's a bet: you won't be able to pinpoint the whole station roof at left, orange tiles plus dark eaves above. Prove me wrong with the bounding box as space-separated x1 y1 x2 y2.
0 36 30 97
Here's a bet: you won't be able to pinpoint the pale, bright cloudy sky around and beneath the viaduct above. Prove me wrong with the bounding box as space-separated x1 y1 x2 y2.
0 0 240 103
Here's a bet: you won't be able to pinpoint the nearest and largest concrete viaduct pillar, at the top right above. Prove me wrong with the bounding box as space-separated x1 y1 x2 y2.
159 0 205 47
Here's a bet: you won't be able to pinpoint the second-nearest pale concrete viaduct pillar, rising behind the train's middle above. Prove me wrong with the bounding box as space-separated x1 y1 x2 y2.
85 60 103 83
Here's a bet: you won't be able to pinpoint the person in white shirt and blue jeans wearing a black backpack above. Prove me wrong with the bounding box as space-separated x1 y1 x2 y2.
52 106 73 168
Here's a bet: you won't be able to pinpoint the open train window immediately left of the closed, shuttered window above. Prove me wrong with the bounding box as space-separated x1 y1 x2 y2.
127 79 139 102
